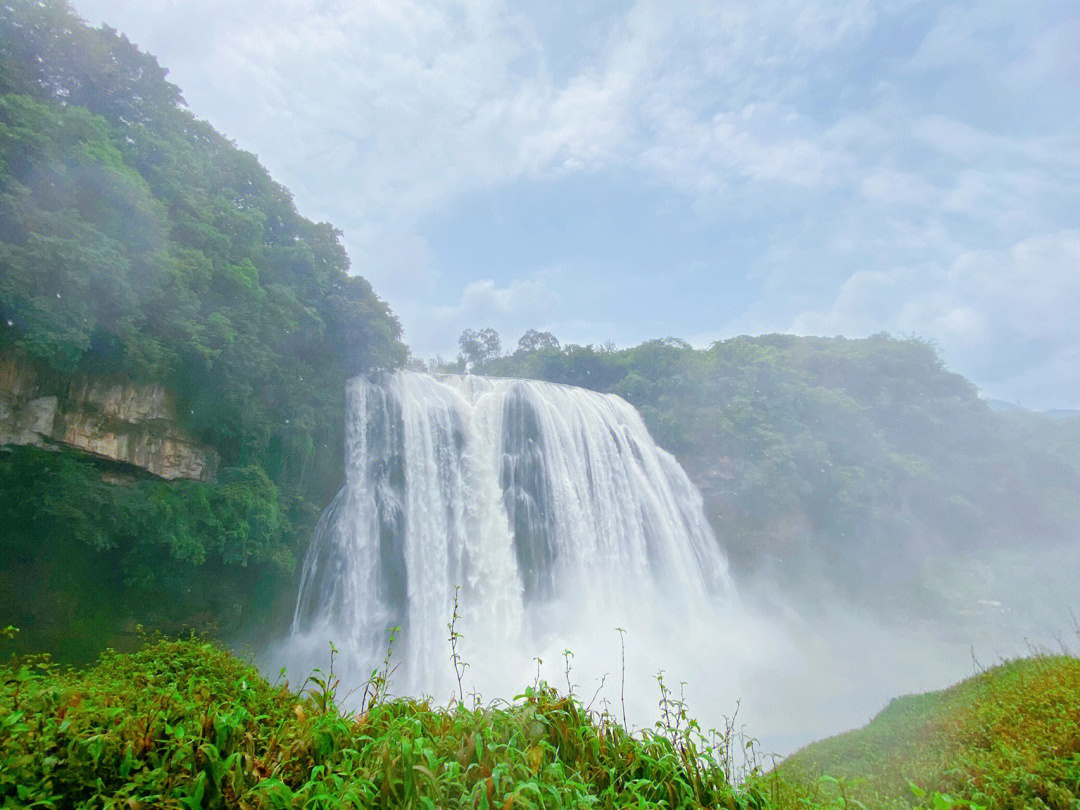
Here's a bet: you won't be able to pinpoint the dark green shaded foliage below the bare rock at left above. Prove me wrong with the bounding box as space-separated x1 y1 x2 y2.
0 447 295 660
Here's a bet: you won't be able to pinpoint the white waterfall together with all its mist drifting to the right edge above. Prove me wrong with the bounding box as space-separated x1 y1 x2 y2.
260 373 1080 764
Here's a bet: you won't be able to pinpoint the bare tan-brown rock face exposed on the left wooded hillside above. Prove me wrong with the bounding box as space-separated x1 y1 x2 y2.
0 355 217 481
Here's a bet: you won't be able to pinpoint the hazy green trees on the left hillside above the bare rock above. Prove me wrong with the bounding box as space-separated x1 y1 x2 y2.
0 0 405 468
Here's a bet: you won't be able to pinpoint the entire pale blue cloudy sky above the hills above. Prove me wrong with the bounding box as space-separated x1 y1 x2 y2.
75 0 1080 408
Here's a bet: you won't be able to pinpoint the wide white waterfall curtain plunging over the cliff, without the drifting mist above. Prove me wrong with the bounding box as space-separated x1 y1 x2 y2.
288 372 732 700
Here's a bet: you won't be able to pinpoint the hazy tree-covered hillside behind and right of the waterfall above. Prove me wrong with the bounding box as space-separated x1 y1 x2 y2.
479 335 1080 615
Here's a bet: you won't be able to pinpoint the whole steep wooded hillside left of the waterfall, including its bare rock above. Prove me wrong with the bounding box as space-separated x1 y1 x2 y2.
0 0 407 658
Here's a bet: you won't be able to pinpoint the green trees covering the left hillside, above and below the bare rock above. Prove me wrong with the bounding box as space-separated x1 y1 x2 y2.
0 0 406 656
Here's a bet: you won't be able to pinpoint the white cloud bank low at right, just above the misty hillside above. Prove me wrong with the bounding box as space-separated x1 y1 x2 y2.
789 230 1080 407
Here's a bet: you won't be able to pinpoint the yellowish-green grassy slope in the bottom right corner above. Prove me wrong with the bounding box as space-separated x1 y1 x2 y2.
779 657 1080 810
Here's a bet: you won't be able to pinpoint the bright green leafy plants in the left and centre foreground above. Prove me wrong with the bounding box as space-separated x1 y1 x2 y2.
0 640 767 809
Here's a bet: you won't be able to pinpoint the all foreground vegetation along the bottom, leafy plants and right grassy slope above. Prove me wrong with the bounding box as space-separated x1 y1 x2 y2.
0 639 1080 810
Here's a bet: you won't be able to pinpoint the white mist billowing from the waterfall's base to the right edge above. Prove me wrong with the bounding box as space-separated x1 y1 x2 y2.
270 527 1080 765
